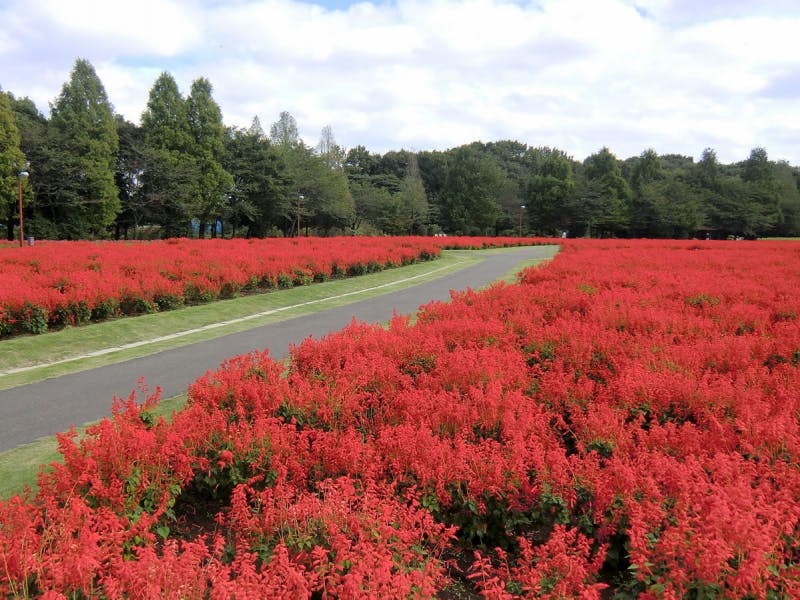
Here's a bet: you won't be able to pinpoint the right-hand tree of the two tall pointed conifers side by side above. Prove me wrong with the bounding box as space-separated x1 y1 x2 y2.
186 77 233 238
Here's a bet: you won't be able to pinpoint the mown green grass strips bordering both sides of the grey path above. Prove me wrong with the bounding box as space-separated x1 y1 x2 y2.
0 247 557 499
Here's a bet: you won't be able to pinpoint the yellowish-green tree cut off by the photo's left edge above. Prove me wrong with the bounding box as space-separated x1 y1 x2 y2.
0 91 25 241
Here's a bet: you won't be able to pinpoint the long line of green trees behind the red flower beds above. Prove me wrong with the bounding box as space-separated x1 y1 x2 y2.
0 59 800 240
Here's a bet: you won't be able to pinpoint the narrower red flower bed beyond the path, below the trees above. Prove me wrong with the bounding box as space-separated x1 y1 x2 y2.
0 237 537 338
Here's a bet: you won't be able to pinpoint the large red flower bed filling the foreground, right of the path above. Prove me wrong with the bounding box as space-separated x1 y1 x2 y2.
0 240 800 599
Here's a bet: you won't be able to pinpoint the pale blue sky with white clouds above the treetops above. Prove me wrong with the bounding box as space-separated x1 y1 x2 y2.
0 0 800 165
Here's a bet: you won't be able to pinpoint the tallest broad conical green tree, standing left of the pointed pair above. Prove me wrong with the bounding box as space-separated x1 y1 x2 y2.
50 59 120 238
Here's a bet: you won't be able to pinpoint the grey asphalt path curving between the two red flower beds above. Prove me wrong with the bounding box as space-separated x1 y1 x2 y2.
0 246 553 452
